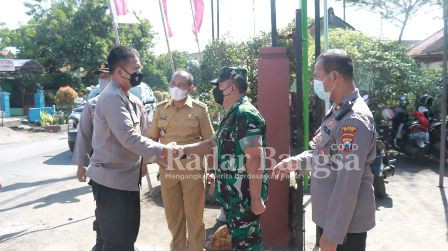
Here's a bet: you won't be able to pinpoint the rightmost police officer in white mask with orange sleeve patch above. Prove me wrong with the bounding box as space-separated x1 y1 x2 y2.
273 50 376 251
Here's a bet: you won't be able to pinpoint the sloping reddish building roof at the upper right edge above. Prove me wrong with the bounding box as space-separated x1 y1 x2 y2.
408 28 443 58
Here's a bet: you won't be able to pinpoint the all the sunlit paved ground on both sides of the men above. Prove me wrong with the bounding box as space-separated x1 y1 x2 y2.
0 133 448 251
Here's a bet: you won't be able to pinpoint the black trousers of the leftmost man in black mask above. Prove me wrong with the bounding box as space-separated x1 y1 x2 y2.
89 180 140 251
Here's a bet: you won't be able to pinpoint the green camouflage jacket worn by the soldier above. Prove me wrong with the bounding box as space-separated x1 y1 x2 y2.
214 96 268 210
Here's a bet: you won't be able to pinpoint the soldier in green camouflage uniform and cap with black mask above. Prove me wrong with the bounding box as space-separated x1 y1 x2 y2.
183 67 268 250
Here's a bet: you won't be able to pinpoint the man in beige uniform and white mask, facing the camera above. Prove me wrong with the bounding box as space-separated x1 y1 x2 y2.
149 71 213 251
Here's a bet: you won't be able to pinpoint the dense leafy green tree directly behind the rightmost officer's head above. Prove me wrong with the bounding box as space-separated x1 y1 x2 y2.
329 29 440 117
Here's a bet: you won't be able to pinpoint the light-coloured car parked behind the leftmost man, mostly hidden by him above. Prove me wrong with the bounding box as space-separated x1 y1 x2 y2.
67 82 157 152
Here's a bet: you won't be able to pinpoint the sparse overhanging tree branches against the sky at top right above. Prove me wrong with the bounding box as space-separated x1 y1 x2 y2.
339 0 442 42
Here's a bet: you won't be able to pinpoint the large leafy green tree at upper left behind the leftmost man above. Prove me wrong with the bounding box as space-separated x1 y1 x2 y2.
0 0 157 90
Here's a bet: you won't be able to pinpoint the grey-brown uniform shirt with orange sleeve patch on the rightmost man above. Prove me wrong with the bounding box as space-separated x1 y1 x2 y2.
298 90 376 244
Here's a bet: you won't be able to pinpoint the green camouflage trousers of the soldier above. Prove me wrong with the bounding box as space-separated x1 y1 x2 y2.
224 207 263 251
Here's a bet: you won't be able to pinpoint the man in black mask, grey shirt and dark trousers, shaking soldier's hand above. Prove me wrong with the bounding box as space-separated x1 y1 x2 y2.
87 45 178 251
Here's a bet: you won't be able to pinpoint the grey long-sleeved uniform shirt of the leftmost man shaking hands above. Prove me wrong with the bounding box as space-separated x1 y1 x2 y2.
87 81 164 191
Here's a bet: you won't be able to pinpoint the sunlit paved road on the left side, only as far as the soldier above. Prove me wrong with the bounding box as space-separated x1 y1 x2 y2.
0 133 219 251
